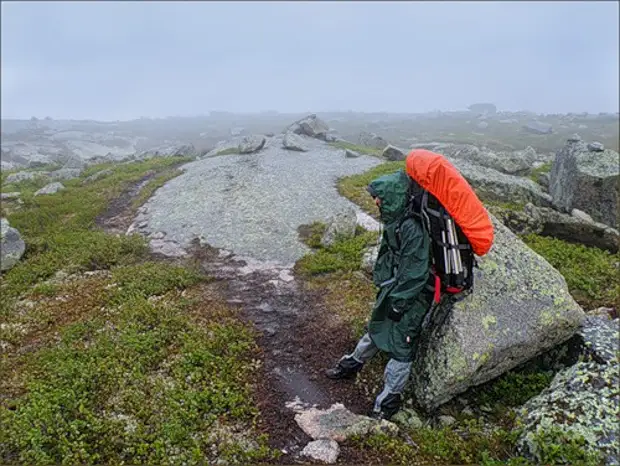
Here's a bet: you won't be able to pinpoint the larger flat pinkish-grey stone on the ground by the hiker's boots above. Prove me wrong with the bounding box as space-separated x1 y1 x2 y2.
295 403 398 442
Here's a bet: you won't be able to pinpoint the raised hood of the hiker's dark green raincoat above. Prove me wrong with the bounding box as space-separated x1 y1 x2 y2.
368 170 409 225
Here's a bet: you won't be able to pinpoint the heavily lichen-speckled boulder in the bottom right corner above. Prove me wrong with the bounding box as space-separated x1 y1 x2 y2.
517 362 620 465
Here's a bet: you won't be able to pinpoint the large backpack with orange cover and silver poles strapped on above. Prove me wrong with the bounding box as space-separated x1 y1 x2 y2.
405 149 494 303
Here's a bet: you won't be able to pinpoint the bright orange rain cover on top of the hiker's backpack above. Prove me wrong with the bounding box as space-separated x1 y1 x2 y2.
405 149 493 256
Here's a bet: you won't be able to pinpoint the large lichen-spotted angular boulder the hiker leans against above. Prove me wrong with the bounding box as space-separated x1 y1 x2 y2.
413 216 585 411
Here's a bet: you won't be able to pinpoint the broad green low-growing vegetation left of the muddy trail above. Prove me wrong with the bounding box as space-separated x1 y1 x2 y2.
0 158 274 465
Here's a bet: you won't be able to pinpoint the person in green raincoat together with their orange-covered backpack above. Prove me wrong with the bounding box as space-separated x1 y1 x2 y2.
326 149 494 420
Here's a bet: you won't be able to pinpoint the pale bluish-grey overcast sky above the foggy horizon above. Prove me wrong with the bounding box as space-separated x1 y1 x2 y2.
1 1 619 120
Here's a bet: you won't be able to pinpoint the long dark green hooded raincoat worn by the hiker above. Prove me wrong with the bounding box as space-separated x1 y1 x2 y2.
368 170 432 362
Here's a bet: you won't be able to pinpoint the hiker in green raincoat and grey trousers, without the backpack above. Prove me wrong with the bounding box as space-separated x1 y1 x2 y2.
326 170 433 420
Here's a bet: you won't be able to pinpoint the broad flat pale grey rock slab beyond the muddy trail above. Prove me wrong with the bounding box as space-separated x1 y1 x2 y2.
135 137 380 264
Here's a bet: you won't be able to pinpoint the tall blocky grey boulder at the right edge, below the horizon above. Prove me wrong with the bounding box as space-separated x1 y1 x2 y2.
549 136 620 228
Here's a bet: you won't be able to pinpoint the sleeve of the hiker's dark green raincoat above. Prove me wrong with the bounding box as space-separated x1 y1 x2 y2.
389 219 429 313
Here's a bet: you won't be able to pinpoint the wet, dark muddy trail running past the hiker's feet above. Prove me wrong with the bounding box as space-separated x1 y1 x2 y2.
191 243 372 464
